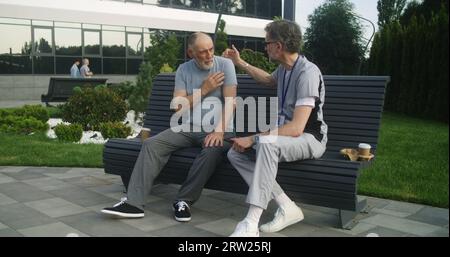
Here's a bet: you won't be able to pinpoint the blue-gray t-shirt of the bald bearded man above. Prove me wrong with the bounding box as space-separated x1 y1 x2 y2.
175 56 237 131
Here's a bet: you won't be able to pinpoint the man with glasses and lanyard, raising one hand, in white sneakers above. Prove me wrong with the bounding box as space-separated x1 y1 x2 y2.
223 20 327 237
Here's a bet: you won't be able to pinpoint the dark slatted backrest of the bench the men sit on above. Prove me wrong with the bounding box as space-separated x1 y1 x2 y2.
144 73 389 153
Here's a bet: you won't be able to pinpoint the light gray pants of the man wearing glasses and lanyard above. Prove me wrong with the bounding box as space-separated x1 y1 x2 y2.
228 133 325 209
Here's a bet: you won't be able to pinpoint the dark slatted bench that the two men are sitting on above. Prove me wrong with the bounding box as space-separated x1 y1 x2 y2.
103 74 389 229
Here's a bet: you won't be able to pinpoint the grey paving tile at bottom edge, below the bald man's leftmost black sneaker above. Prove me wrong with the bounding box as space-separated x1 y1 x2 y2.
59 212 146 237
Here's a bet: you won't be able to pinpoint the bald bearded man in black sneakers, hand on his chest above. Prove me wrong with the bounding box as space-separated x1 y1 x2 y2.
102 32 237 222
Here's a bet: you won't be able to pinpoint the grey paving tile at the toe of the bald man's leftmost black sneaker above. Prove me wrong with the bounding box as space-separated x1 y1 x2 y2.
48 187 114 207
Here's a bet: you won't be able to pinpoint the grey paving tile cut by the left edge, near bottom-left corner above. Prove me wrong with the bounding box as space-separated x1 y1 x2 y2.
0 203 55 229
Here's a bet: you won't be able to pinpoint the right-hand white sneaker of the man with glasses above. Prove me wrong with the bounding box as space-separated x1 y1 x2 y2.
259 202 304 233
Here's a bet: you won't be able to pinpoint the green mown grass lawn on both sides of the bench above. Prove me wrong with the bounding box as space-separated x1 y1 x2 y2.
0 113 449 208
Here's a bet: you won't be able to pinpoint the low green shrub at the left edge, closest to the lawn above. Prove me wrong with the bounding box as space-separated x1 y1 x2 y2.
0 115 48 135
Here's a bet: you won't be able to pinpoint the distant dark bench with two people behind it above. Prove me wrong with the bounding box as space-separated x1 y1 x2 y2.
41 77 108 106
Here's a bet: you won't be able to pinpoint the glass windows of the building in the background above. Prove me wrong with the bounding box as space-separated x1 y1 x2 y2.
0 0 282 75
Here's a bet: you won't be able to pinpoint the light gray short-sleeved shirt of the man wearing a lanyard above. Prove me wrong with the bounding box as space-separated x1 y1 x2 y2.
272 56 328 144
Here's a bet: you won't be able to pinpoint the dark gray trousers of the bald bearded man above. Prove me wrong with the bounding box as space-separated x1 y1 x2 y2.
127 129 231 209
